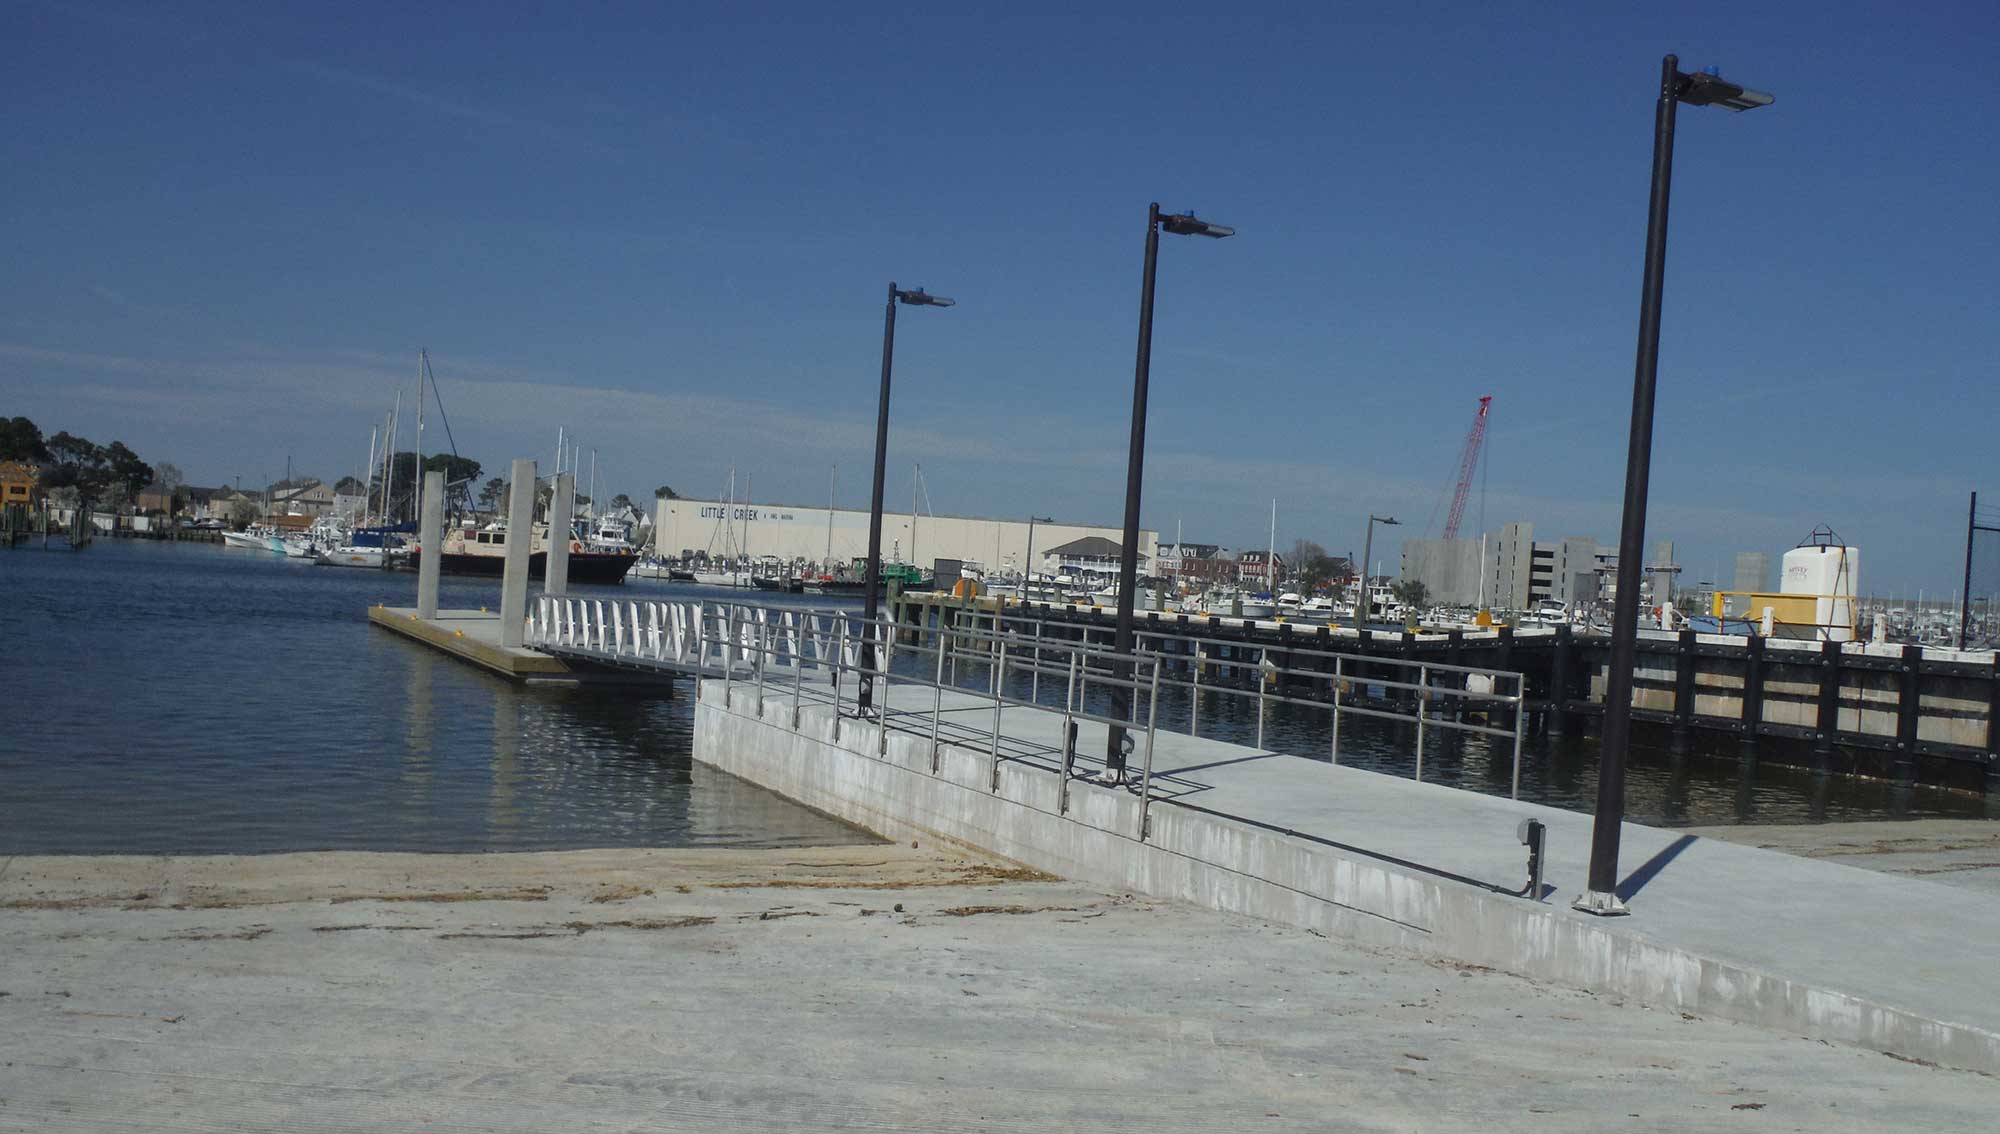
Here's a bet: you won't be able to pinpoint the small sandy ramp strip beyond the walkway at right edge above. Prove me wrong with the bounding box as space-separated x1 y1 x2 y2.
1688 820 2000 894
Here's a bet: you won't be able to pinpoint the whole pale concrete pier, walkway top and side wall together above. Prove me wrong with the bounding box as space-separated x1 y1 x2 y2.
694 680 2000 1072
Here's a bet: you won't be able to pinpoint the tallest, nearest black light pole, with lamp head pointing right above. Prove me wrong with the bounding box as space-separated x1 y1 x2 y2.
1576 56 1772 914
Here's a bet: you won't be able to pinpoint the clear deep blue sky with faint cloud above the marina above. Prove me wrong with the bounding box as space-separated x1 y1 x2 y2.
0 2 2000 592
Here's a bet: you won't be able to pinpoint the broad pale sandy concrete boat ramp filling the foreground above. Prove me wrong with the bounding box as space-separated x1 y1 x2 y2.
0 844 2000 1132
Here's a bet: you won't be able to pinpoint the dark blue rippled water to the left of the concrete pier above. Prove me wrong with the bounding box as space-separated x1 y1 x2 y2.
0 540 868 854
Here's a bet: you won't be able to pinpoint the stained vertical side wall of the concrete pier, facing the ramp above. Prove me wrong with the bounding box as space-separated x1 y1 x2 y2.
694 680 2000 1072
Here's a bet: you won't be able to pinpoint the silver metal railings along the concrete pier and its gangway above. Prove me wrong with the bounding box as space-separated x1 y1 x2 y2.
526 594 1526 840
